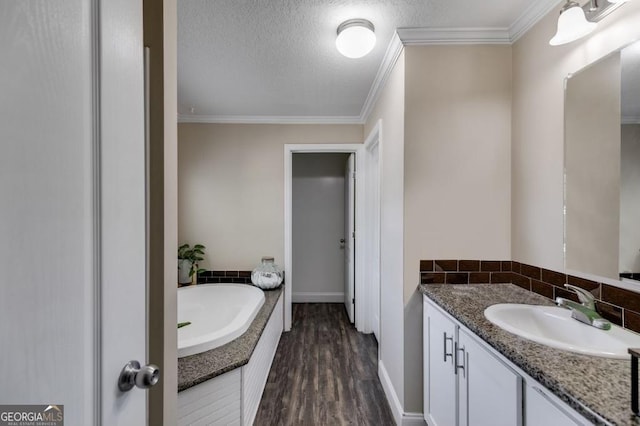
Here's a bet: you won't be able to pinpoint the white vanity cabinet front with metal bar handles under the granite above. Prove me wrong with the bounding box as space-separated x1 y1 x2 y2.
423 296 590 426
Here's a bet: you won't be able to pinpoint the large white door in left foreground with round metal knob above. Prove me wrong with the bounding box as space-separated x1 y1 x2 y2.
0 0 146 425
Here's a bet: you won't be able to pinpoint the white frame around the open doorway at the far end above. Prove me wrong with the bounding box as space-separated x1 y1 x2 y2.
284 143 368 332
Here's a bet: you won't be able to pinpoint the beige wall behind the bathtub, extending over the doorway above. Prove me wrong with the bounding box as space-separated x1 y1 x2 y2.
178 123 363 270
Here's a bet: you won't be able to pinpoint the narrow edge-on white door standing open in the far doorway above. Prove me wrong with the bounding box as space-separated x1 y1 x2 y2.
344 154 356 323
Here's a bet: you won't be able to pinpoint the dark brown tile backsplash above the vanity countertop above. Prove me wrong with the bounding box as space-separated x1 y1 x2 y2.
420 260 640 332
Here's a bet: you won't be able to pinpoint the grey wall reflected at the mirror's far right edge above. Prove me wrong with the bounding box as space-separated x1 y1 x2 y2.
620 124 640 273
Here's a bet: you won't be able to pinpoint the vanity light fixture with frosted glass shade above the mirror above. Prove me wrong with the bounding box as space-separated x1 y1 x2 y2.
549 0 630 46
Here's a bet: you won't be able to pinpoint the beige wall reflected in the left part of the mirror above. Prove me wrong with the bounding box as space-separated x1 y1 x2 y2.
564 54 620 279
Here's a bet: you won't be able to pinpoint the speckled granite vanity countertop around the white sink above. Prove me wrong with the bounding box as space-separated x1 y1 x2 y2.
419 284 640 425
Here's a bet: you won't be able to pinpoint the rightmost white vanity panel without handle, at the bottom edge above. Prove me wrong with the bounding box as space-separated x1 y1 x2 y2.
525 386 590 426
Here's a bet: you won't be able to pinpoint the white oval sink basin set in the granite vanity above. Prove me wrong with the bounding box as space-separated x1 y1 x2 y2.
484 303 640 359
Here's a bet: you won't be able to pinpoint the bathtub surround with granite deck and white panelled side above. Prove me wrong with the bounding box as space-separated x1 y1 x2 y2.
177 284 283 426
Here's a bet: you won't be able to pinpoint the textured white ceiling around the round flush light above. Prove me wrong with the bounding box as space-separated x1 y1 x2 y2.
178 0 557 121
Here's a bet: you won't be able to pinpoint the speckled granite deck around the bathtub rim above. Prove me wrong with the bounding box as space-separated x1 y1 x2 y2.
178 286 284 392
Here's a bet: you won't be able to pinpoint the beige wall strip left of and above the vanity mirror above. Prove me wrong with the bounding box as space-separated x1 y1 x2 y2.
511 2 640 271
